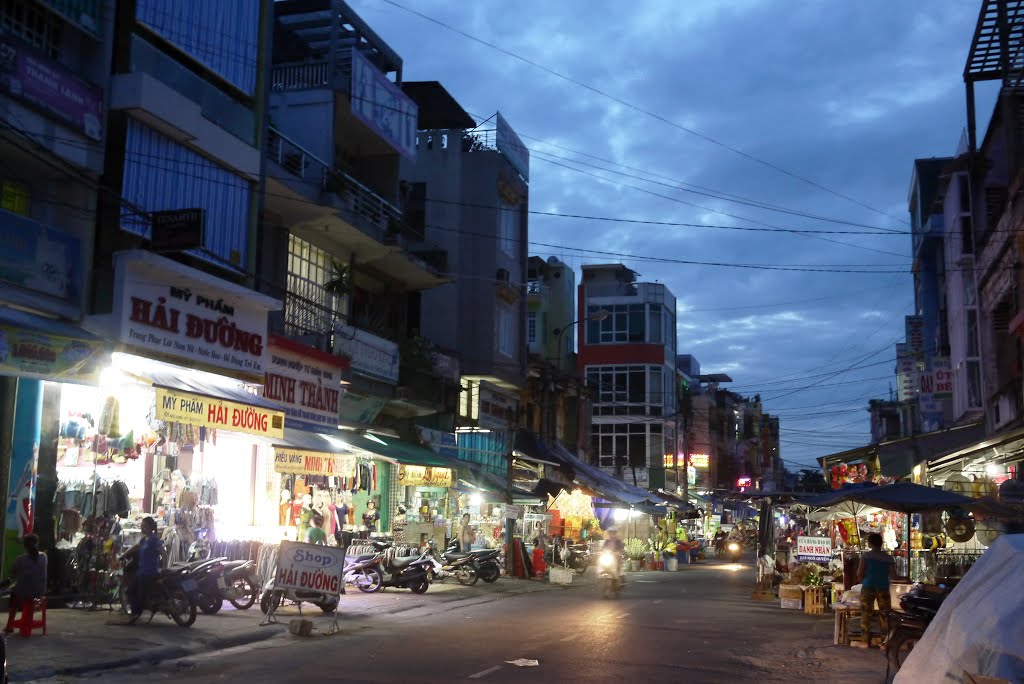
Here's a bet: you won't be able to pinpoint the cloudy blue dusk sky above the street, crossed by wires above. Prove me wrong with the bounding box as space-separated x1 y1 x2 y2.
350 0 993 470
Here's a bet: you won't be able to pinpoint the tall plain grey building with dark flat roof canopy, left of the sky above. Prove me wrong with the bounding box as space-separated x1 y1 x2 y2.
401 81 529 472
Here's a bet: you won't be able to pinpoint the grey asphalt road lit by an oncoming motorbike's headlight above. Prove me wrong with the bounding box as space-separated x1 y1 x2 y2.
41 563 885 684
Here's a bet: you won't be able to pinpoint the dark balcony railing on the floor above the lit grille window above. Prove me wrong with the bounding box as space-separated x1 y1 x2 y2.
267 128 425 244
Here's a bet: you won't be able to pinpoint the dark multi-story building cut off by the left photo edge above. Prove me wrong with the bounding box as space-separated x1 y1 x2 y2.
0 0 115 557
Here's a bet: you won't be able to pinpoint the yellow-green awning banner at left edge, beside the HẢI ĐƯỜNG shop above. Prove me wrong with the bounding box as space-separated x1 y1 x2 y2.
0 324 105 384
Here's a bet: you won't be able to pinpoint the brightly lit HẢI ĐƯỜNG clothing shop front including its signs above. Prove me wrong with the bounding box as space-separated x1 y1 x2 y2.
44 251 285 593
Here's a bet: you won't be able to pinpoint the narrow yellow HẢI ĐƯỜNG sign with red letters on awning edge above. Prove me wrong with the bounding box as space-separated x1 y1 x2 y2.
157 387 285 439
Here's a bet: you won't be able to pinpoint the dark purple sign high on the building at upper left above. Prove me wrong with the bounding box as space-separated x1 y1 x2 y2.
0 34 103 140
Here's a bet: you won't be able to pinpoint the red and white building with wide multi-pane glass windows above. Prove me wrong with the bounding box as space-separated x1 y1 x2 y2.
578 264 680 489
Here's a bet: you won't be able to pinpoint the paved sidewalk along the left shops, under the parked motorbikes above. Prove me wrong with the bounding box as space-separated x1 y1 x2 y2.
7 578 581 682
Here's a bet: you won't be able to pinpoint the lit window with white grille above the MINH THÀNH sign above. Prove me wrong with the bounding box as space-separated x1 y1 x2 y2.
285 236 341 335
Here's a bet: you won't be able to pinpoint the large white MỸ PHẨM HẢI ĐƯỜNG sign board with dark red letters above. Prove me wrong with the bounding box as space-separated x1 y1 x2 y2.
115 253 280 377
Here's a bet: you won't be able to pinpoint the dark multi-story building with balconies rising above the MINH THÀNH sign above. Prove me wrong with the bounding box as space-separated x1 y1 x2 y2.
261 0 458 446
